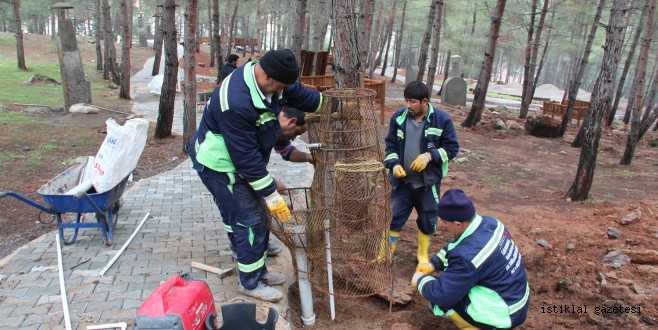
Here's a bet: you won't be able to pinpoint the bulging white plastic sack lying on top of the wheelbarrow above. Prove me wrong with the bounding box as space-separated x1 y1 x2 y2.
92 118 149 193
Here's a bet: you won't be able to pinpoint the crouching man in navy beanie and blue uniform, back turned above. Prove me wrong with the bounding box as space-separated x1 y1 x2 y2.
411 189 530 330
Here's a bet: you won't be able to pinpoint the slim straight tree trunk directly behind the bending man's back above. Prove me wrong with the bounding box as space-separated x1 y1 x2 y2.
183 0 197 152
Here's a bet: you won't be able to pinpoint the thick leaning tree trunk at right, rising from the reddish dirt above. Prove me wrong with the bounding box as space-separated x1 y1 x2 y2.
565 0 628 201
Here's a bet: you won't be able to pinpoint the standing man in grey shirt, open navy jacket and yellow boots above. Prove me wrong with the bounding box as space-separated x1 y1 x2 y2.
379 81 459 274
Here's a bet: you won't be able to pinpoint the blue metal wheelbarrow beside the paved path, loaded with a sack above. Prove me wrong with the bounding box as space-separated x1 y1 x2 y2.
0 157 130 246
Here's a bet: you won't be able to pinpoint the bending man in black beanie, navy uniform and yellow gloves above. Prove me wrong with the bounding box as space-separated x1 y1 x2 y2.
188 49 322 302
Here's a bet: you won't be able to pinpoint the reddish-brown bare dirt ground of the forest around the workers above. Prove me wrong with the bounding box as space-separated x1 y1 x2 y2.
0 35 658 329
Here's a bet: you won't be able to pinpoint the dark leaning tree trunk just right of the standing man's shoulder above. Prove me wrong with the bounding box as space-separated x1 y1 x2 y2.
462 0 507 127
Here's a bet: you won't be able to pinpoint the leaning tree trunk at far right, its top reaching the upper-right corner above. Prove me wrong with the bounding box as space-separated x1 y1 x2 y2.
619 0 656 165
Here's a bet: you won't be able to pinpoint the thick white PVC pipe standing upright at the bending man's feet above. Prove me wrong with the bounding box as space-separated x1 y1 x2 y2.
292 226 315 325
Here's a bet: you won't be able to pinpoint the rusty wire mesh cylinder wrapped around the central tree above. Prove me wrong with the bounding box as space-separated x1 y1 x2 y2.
305 89 392 297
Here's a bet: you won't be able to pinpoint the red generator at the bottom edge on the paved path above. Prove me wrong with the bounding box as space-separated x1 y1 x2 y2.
133 275 215 330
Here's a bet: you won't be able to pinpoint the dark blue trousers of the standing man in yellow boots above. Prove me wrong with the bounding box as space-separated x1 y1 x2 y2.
391 181 441 235
